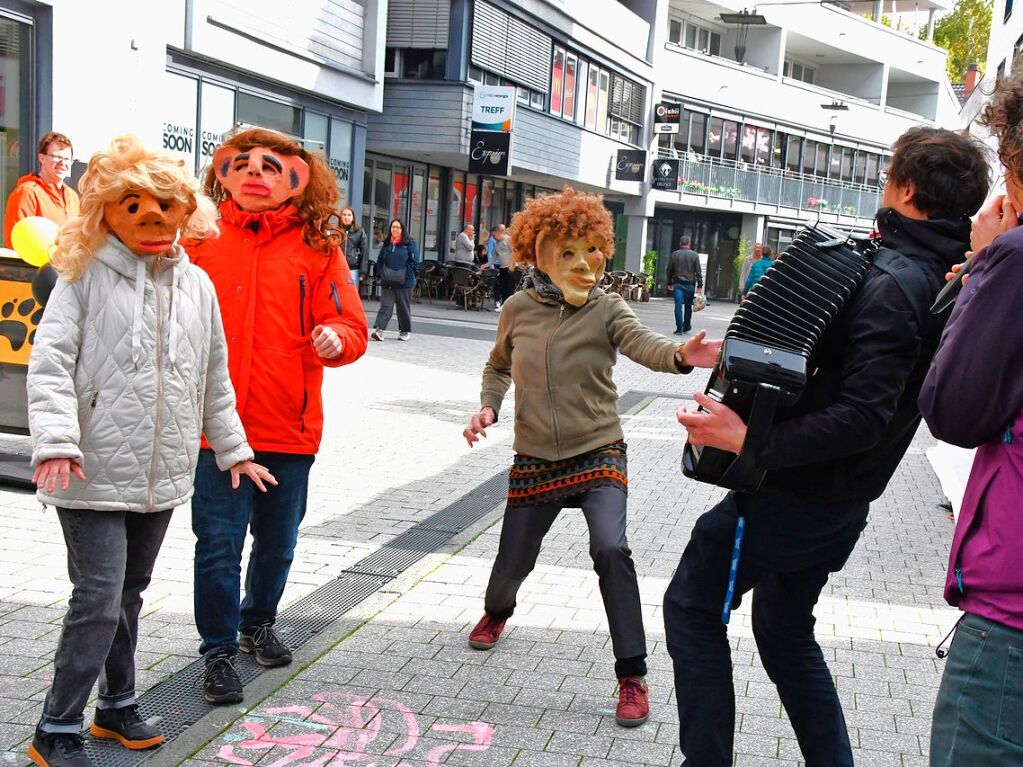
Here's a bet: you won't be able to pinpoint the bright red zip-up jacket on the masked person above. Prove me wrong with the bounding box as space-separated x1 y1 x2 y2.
186 199 366 455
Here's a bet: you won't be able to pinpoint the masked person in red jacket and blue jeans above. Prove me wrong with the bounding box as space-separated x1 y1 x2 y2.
187 128 367 704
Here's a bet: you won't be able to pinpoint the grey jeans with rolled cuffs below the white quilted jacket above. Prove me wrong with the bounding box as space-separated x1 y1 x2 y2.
39 508 172 732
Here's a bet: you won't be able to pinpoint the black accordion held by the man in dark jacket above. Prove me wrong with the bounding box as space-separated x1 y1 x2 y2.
682 224 873 492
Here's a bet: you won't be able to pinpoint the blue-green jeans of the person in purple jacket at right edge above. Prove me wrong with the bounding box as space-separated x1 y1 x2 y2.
931 613 1023 767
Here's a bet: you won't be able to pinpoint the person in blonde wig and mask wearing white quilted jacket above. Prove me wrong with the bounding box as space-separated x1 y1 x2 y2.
28 136 275 767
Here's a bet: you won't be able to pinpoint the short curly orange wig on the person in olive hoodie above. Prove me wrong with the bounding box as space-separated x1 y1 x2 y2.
512 186 615 266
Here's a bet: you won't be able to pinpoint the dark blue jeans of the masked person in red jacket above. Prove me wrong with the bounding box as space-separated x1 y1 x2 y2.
192 450 315 656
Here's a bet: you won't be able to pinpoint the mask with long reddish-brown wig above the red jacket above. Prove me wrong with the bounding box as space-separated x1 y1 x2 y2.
205 128 344 253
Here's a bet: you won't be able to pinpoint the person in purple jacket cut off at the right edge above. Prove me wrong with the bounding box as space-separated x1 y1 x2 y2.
920 73 1023 767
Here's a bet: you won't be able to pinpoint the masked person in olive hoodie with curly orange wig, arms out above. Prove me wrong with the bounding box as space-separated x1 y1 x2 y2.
463 189 720 726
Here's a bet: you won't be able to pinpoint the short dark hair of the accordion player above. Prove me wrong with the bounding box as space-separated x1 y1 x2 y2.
888 126 991 219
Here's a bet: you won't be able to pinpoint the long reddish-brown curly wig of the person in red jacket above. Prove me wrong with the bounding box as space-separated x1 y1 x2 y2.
204 128 345 255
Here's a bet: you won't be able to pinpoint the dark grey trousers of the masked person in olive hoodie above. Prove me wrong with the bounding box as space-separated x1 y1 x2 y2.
484 487 647 678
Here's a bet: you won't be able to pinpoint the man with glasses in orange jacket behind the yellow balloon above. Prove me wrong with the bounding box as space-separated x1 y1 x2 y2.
3 131 79 247
